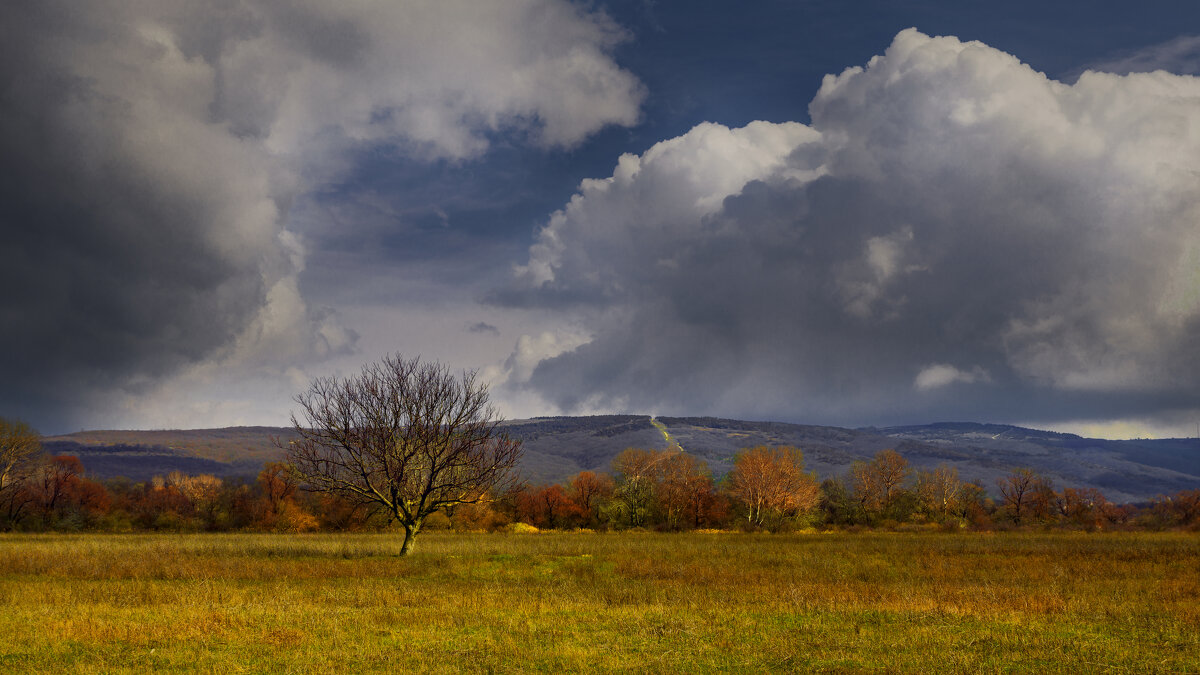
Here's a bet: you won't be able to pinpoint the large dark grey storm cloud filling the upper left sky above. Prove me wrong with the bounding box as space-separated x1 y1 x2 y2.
0 0 643 425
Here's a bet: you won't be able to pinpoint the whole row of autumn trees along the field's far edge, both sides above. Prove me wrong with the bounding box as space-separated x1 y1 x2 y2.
0 419 1200 532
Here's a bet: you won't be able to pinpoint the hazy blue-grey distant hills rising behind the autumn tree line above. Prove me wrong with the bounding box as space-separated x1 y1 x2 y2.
43 414 1200 502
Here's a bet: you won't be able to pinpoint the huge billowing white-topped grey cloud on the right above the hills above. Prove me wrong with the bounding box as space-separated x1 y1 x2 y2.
504 30 1200 424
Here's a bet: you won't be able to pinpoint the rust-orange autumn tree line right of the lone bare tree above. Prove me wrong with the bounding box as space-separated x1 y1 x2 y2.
504 446 1200 532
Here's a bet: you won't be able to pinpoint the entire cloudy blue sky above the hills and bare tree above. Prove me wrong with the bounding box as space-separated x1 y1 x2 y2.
0 0 1200 437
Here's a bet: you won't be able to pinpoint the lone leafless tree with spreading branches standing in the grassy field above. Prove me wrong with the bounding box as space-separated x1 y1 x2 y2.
285 356 521 555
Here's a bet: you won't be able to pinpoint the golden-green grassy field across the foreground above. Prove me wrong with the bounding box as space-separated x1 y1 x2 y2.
0 532 1200 673
